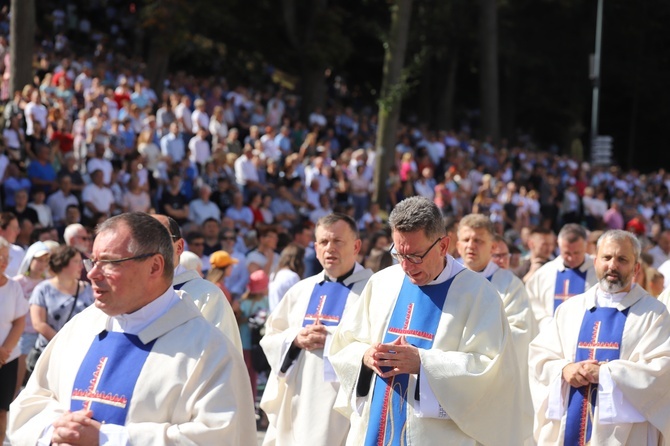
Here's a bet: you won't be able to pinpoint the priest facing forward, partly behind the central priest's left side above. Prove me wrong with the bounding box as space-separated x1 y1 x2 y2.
261 214 372 446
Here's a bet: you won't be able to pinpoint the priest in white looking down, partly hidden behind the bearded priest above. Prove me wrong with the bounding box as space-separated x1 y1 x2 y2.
526 223 597 329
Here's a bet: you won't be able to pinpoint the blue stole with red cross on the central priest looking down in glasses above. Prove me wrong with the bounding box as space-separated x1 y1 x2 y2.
365 276 456 446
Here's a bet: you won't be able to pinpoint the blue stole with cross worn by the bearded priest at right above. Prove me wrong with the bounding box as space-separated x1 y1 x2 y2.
563 308 628 446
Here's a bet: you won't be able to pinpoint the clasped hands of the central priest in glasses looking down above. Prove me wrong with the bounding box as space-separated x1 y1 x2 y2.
363 336 421 378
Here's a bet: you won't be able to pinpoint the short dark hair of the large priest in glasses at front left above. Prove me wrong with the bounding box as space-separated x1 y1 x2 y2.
95 212 174 281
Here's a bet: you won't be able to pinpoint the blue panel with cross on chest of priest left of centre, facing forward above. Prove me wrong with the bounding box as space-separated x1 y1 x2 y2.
302 281 350 327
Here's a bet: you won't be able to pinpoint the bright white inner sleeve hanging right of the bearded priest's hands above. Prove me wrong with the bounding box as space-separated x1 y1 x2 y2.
598 365 647 424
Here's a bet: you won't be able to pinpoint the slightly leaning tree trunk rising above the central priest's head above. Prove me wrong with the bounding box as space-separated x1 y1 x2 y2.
372 0 412 209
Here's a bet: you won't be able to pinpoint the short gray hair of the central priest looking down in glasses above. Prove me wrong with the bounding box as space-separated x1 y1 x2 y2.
389 196 444 239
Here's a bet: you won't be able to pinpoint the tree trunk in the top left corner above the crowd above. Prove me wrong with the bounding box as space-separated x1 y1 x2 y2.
9 0 35 95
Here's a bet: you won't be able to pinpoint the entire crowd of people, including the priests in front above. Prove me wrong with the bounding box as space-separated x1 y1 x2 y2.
0 2 670 445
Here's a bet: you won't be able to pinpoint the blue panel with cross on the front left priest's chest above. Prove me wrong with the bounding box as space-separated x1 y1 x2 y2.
70 331 156 426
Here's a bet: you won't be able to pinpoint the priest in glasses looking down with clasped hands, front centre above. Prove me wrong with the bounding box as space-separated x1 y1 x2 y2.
331 197 523 446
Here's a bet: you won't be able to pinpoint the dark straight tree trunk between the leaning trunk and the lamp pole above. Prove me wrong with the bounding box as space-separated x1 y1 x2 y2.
479 0 500 143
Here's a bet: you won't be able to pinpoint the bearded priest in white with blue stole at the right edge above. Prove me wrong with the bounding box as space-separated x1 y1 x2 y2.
529 230 670 446
